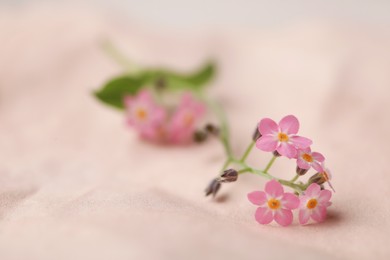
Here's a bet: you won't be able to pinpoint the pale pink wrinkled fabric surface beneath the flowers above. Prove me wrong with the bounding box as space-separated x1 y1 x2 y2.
0 6 390 259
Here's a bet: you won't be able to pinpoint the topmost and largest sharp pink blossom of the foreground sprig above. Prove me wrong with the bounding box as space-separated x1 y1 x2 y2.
256 115 312 158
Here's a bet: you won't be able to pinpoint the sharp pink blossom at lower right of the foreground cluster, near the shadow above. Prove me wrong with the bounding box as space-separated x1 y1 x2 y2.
299 183 332 225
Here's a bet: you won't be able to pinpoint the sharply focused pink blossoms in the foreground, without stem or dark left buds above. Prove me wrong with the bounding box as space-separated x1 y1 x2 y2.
248 115 333 226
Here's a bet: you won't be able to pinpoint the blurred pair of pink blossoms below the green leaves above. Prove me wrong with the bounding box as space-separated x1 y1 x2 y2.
124 89 205 144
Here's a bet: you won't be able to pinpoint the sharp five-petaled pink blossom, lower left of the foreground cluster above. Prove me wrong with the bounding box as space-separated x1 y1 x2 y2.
248 180 299 226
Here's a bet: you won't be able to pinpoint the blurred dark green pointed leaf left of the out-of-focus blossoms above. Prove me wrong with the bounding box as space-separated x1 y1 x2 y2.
94 76 146 109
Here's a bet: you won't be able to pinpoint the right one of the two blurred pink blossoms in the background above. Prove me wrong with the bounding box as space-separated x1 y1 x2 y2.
170 93 205 143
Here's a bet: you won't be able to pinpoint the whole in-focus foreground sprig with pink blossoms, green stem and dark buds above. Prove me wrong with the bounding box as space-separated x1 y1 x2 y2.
206 115 334 226
